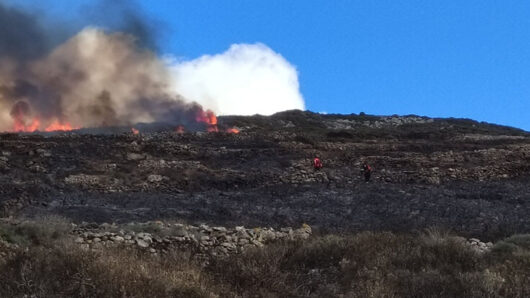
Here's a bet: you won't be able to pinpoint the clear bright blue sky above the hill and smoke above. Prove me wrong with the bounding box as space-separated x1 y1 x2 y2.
5 0 530 130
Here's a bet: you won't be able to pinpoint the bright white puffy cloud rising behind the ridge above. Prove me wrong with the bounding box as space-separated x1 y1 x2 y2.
173 44 304 115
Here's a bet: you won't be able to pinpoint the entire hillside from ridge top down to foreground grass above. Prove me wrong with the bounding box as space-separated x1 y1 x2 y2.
0 111 530 297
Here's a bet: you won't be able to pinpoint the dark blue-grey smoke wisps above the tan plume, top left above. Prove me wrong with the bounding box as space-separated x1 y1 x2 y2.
0 0 161 62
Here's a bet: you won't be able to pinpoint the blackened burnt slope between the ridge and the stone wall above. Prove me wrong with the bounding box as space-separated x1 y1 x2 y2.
0 111 530 239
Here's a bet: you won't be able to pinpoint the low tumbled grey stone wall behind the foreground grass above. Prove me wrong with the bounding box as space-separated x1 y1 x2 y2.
73 222 312 255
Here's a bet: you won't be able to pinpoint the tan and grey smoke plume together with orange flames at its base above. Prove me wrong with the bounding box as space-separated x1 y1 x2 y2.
0 5 234 133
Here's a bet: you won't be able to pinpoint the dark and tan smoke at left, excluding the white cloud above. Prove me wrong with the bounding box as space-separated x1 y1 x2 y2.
0 0 185 131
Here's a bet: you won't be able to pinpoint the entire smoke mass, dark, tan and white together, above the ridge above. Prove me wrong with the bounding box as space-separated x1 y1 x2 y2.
0 1 303 131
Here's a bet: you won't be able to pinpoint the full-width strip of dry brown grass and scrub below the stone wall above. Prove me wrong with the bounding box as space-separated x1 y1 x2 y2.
0 223 530 297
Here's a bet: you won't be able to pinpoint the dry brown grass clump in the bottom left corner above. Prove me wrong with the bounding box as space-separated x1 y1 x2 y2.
0 242 208 297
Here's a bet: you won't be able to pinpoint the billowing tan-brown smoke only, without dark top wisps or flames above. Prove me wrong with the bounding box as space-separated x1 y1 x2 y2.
0 28 204 130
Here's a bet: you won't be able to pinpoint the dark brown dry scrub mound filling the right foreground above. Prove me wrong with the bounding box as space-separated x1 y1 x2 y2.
208 231 530 297
